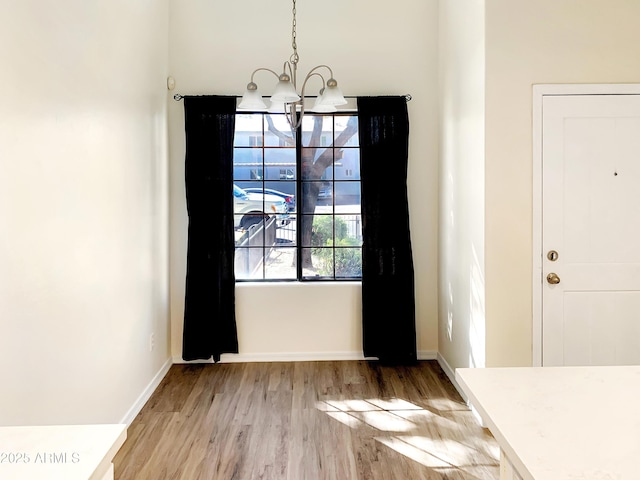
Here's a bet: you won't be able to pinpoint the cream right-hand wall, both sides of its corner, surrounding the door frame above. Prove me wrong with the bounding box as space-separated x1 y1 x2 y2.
439 0 640 368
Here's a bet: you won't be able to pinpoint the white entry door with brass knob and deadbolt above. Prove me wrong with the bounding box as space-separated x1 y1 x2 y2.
541 95 640 366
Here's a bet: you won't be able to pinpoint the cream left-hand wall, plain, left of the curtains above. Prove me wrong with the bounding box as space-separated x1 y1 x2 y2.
0 0 169 425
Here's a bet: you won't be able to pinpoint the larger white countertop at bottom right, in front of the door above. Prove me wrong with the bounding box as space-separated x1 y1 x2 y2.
456 366 640 480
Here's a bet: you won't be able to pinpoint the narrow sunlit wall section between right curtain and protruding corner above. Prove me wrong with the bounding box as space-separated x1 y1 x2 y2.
438 0 485 369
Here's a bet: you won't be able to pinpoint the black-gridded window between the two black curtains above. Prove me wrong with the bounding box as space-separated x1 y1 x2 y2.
233 113 362 281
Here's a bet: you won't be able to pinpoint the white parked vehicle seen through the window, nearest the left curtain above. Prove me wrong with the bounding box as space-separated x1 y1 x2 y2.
233 184 289 228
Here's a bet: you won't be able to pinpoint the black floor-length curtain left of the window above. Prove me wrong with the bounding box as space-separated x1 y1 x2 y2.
182 96 238 362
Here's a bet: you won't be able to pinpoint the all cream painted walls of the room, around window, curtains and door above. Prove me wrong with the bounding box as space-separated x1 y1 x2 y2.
0 0 640 424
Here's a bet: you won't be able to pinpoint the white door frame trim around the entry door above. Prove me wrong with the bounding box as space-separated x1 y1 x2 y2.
532 83 640 367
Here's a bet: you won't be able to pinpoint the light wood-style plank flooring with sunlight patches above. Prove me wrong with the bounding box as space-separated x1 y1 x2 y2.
114 361 499 480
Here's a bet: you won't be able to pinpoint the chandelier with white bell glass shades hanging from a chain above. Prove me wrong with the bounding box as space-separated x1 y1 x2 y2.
238 0 347 129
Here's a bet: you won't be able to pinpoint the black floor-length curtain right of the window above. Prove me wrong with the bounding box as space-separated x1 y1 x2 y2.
358 96 417 364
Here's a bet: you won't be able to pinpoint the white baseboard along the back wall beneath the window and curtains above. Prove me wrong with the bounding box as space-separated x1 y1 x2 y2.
173 350 437 363
